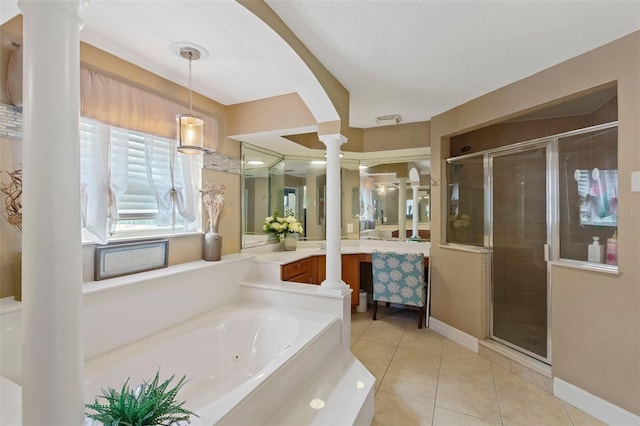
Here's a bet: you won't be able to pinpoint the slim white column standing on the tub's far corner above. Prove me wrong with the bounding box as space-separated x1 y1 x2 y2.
320 135 348 290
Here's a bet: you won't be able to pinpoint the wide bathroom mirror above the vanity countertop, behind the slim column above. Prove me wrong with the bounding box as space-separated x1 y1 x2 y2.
242 143 430 248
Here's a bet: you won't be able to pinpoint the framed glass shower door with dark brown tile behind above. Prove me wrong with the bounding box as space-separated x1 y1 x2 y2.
488 144 550 362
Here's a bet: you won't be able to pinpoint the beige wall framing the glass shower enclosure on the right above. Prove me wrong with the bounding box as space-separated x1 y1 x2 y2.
431 32 640 414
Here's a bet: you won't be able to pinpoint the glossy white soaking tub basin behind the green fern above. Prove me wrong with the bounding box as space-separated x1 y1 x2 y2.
85 304 350 425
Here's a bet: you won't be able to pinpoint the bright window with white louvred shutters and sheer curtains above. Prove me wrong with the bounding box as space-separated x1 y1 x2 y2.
80 118 202 242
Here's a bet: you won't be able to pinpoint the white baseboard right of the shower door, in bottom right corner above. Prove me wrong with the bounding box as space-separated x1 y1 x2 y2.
553 377 640 426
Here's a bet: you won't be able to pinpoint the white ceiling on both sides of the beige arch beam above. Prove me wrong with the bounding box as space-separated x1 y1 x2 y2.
0 0 640 139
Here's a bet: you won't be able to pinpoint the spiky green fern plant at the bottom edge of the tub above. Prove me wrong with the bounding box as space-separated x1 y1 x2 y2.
85 370 198 426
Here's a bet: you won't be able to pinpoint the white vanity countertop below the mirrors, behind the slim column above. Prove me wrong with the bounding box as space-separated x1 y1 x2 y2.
250 240 431 265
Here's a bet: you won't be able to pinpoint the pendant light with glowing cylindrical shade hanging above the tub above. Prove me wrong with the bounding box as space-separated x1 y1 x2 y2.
176 46 209 154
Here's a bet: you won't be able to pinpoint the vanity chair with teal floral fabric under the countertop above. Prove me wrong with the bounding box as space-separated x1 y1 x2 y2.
371 251 426 328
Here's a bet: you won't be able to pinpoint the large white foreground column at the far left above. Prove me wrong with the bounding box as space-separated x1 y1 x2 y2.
20 0 84 425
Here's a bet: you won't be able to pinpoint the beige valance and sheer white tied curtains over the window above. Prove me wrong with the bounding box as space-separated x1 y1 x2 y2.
80 69 212 238
